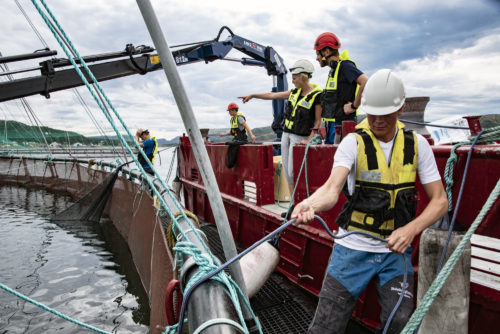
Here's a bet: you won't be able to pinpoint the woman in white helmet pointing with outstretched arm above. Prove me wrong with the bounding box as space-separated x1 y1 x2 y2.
239 59 322 217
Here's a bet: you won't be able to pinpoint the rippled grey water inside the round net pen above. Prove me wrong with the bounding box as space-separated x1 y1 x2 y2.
0 185 149 333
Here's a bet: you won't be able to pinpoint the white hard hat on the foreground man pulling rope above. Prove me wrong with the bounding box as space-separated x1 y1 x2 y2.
359 69 406 116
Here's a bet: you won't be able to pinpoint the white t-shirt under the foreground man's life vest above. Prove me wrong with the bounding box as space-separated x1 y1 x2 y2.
332 132 441 253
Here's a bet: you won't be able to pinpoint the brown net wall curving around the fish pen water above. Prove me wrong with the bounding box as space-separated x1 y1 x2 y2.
0 159 173 333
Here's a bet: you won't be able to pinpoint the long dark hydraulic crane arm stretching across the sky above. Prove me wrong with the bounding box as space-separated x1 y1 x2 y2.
0 26 288 137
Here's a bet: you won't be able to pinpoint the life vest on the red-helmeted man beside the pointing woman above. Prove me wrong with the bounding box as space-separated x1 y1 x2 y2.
321 50 359 122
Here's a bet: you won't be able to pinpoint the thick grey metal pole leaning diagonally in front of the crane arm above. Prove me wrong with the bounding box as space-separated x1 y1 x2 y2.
136 0 249 306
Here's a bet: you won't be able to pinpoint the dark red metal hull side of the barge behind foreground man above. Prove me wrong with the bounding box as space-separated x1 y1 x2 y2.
178 136 500 333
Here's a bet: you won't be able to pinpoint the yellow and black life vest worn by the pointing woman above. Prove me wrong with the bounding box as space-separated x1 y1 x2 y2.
285 84 322 136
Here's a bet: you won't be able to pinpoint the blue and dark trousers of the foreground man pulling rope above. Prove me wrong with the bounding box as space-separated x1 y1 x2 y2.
308 244 414 334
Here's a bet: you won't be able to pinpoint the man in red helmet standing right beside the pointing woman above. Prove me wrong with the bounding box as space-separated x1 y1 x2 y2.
314 32 368 144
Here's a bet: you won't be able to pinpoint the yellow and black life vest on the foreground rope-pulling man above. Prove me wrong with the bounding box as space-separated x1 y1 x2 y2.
337 119 418 238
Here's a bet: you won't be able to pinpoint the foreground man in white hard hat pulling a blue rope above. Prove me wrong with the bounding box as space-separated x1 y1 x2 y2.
292 69 448 334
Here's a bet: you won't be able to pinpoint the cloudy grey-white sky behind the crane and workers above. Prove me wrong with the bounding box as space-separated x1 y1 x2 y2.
0 0 500 138
